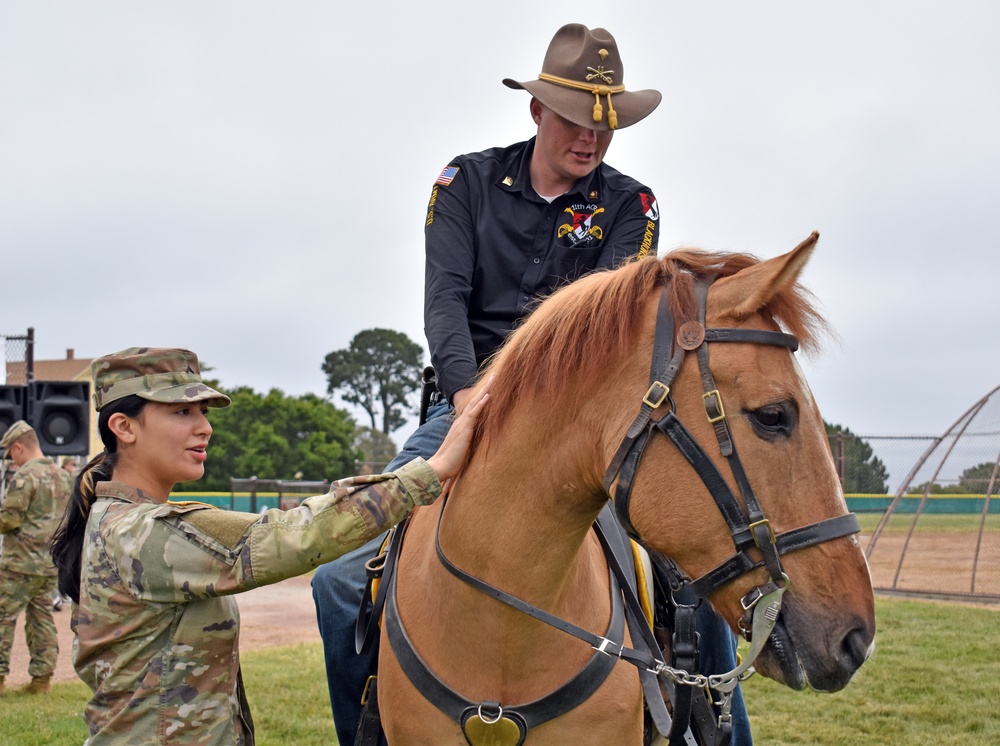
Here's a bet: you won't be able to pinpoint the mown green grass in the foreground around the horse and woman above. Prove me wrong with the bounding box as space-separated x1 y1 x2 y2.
0 598 1000 746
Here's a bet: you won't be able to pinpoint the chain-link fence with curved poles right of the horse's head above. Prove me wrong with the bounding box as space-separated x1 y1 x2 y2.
848 386 1000 602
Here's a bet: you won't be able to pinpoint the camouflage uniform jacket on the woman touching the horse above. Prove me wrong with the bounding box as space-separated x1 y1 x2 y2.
72 459 441 746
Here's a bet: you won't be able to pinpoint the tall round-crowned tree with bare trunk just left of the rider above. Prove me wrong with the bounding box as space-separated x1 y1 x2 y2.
323 329 424 435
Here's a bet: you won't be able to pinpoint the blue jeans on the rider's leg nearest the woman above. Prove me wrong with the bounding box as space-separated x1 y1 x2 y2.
312 402 452 746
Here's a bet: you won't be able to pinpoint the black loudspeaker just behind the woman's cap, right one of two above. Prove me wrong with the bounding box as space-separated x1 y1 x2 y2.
28 381 90 456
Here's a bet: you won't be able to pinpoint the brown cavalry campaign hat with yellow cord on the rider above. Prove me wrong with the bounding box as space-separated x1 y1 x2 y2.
503 23 662 131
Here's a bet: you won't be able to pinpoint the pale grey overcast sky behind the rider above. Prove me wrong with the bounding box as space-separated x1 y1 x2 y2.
0 0 1000 442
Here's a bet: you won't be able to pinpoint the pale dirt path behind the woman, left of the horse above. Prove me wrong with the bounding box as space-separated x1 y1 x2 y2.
7 576 320 686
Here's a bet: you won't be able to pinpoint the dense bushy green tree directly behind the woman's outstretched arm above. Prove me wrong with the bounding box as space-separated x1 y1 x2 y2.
179 382 360 492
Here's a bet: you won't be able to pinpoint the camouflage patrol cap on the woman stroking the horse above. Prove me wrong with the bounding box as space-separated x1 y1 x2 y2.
90 347 230 411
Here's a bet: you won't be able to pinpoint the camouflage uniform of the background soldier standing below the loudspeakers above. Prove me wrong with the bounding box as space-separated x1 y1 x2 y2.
0 458 73 678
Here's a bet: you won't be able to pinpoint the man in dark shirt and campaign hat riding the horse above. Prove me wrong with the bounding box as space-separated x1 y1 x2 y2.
313 24 751 746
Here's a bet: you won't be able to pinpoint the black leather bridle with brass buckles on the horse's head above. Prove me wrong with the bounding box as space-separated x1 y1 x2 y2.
604 276 860 715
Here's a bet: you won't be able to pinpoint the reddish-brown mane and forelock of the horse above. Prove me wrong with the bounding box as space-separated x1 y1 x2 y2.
473 249 826 448
